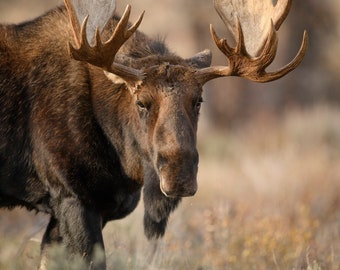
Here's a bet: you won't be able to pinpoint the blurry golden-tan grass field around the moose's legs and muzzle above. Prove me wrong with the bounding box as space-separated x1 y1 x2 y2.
0 106 340 270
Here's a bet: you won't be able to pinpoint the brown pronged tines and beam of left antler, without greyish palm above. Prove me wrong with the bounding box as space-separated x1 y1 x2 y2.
69 2 144 82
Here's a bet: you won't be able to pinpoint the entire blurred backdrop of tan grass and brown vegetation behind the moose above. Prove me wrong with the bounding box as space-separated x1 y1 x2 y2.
0 0 340 270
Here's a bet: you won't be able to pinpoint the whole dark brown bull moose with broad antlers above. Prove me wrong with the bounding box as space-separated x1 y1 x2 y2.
0 0 307 269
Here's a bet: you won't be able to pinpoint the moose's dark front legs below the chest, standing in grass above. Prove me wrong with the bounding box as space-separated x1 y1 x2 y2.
39 198 106 270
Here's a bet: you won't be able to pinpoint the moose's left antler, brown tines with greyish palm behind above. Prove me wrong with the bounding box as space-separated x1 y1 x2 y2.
65 0 144 82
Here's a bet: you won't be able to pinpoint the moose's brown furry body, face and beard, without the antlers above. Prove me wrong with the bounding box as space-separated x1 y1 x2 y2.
0 5 211 268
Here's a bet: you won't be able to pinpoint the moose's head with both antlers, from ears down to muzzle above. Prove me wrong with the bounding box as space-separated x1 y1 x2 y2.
65 0 307 197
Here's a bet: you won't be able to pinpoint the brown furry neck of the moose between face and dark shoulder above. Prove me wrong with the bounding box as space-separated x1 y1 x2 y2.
89 66 143 184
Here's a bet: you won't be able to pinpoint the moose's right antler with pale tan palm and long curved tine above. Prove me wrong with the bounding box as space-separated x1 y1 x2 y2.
197 0 308 83
